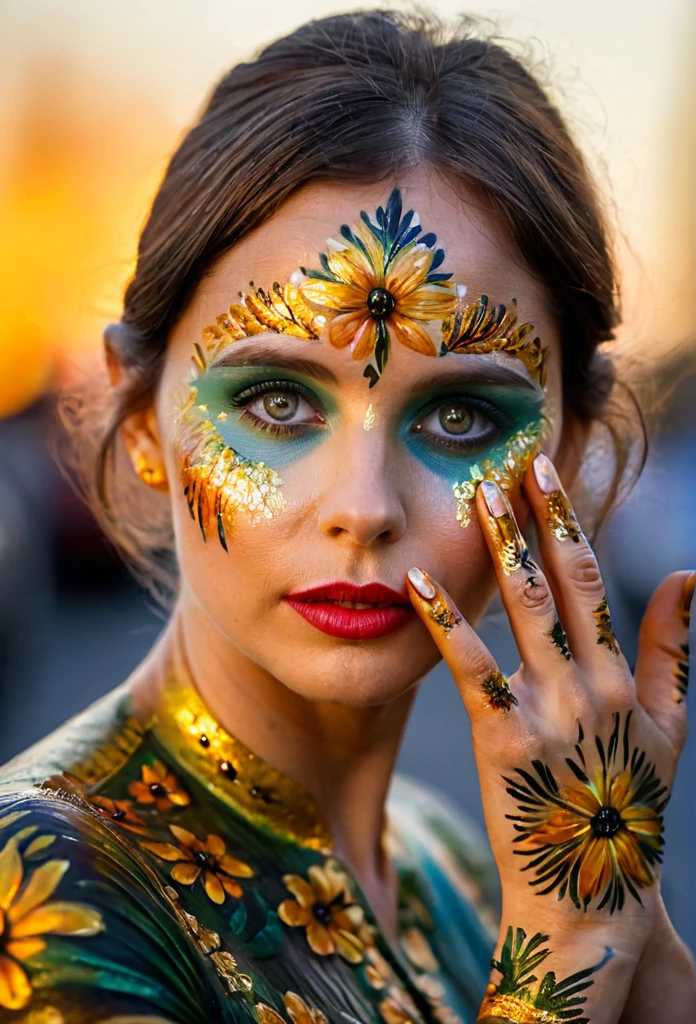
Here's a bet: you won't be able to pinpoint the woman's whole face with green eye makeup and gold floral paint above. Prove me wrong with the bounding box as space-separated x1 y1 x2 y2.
157 169 562 705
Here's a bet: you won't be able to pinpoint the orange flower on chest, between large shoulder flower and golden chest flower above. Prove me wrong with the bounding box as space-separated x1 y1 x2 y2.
141 825 254 904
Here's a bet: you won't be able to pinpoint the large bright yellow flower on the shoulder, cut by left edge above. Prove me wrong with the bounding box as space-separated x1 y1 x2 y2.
0 837 104 1010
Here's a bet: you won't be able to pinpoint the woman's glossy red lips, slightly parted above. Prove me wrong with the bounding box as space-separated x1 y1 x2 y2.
286 581 415 640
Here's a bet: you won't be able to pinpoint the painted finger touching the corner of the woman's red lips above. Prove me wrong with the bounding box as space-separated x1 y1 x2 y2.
406 567 518 718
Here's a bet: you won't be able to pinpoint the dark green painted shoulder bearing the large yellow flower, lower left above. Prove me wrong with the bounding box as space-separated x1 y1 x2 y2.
0 790 225 1024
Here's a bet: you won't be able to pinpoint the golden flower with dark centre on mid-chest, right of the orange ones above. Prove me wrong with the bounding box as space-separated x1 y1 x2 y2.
278 860 364 964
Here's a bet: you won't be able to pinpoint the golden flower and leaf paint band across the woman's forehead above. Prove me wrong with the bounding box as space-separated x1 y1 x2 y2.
197 188 546 387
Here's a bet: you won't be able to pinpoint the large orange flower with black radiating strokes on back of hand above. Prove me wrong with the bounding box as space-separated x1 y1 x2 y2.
505 712 668 913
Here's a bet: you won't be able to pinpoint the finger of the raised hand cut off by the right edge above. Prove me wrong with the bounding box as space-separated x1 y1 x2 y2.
636 572 696 749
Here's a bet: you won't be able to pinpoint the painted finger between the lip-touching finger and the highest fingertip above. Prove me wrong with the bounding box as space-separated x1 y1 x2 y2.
476 480 571 671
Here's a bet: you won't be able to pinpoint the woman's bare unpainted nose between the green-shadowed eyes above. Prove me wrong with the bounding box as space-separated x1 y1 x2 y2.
319 429 406 548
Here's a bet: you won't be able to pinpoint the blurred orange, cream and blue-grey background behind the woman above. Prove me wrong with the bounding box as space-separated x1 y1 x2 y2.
0 0 696 950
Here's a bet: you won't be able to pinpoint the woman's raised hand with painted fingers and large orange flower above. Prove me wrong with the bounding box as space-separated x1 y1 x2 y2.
407 455 696 1024
